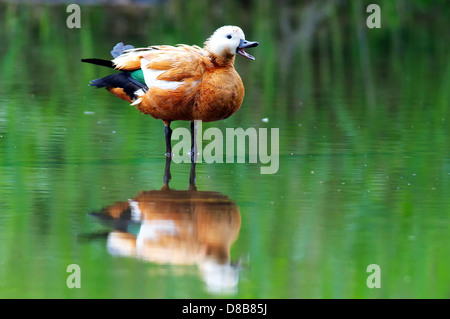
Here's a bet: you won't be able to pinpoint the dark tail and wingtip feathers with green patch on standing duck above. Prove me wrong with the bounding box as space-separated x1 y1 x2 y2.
81 42 148 103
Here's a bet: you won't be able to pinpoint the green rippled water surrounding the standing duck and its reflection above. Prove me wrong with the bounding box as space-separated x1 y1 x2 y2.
0 1 450 298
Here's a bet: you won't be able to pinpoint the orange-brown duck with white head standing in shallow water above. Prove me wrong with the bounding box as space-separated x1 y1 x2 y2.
82 26 258 158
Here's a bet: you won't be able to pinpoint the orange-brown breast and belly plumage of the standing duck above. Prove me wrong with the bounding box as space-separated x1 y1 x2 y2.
133 57 244 122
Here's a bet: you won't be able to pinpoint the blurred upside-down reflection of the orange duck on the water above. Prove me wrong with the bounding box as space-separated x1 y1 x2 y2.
89 160 241 292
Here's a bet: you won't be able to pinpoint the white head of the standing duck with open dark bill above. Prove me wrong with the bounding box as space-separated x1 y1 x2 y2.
204 25 259 60
